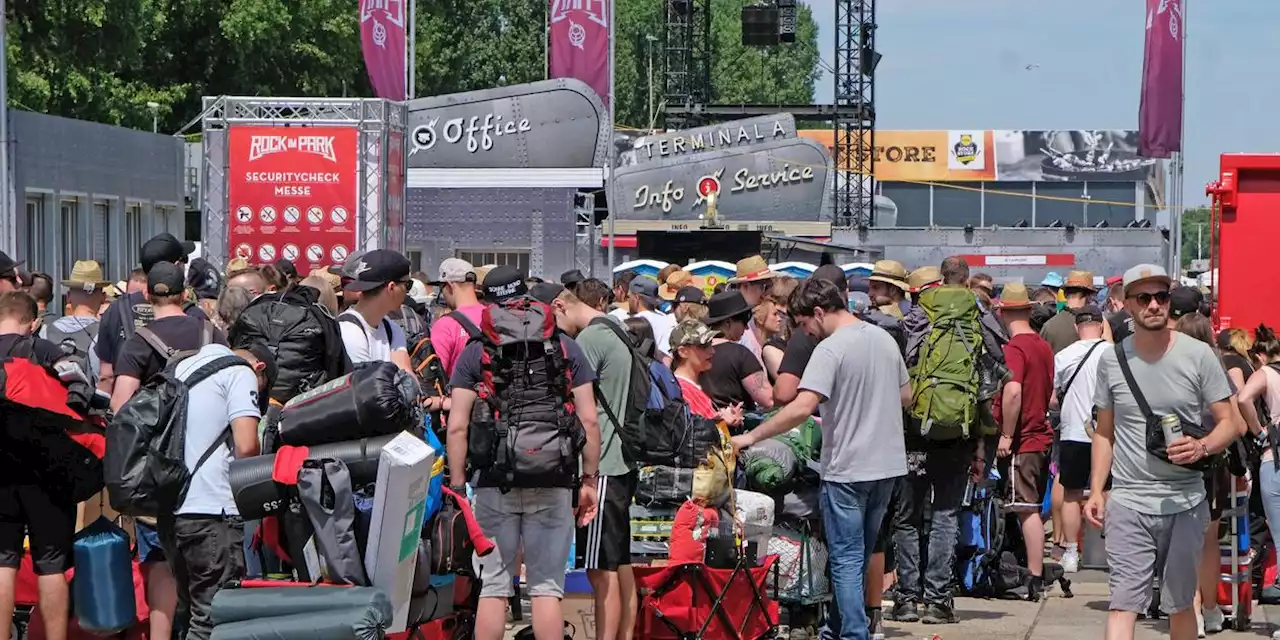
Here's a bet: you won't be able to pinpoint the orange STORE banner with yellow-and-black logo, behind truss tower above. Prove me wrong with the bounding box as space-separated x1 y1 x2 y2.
800 129 996 182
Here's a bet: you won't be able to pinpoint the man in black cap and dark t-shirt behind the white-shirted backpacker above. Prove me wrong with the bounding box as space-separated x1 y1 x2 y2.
107 259 227 637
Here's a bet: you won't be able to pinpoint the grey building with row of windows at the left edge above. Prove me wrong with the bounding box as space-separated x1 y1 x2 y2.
9 110 186 282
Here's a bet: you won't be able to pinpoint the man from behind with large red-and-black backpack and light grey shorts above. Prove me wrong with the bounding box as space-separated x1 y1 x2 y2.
447 266 600 640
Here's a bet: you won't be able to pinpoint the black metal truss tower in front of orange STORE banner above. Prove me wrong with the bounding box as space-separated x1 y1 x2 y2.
832 0 879 227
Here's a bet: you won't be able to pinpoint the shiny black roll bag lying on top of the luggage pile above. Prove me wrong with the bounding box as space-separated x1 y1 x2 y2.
280 362 424 447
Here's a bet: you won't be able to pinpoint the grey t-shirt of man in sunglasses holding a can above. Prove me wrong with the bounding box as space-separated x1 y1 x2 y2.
1093 333 1231 516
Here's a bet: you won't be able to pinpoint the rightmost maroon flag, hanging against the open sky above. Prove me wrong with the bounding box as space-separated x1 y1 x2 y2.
1138 0 1183 157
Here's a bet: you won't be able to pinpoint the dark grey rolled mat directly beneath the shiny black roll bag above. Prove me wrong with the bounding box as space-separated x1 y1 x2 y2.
228 435 396 520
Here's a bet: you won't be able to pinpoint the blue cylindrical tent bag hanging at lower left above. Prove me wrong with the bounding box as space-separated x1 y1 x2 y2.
72 516 137 636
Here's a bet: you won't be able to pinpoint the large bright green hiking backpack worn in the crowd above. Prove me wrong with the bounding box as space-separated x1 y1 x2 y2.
910 285 983 440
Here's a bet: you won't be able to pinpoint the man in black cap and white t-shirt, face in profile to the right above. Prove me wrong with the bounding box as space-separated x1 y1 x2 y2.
338 248 413 374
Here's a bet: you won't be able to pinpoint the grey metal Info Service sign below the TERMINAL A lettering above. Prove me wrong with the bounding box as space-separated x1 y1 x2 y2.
614 138 831 223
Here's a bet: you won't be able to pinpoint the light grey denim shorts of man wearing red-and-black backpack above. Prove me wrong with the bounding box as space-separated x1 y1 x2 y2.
474 488 576 598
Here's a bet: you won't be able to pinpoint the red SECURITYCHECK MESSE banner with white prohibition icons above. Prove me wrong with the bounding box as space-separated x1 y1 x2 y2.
227 127 360 274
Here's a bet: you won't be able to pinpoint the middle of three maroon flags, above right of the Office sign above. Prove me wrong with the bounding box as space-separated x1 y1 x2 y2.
547 0 613 106
